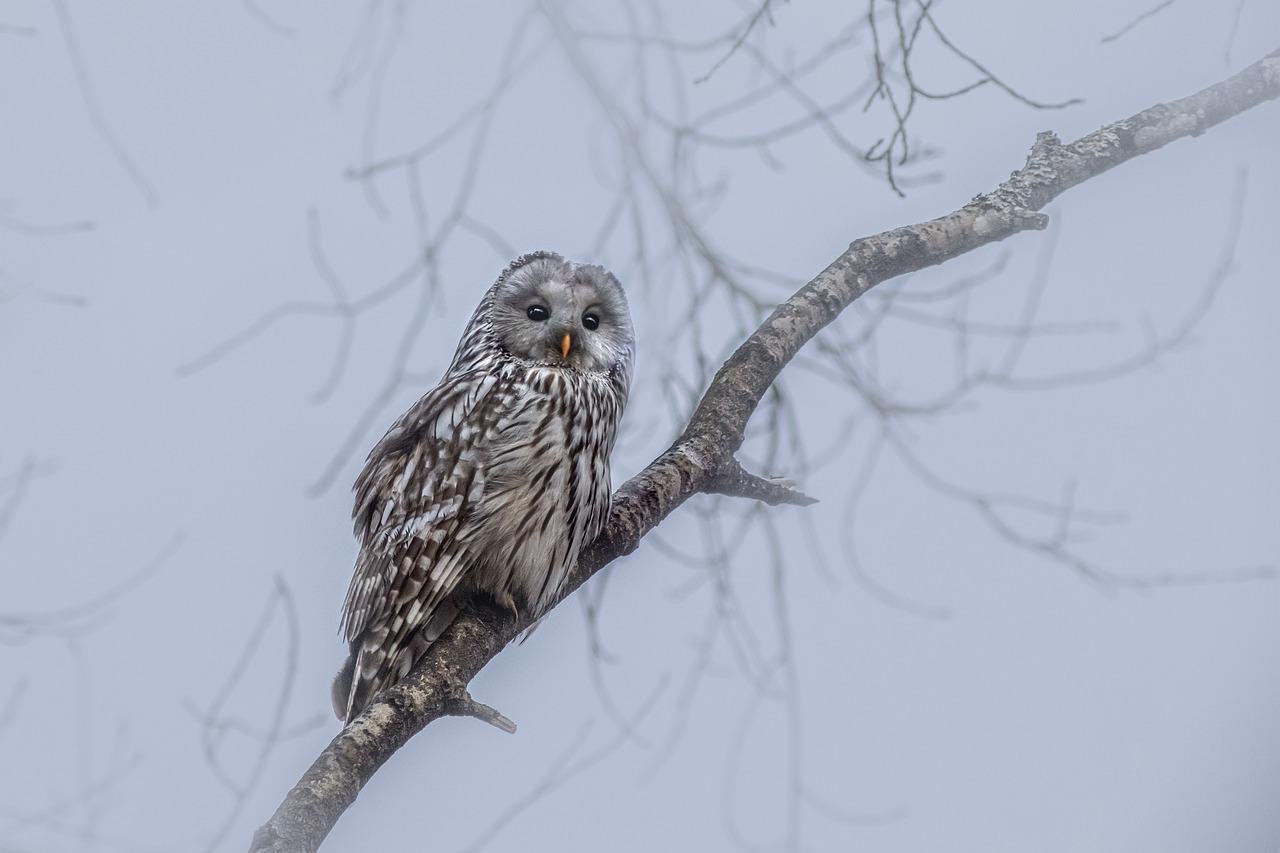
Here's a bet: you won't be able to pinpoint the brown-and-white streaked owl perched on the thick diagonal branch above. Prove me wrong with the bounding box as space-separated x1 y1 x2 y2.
333 252 635 722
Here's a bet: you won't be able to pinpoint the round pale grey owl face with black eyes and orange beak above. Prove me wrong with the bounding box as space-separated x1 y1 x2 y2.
490 252 635 373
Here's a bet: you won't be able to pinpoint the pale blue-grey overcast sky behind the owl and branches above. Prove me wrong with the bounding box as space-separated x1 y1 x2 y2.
0 0 1280 853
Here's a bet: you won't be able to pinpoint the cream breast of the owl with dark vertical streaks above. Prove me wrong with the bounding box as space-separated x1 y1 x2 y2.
471 366 625 617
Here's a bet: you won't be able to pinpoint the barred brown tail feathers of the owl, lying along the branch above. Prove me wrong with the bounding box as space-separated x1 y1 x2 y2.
330 596 462 724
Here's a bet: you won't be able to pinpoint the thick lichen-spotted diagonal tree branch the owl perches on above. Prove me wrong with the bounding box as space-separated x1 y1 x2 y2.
252 50 1280 852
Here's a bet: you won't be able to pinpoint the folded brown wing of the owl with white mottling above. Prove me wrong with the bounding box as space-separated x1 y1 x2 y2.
342 369 513 711
